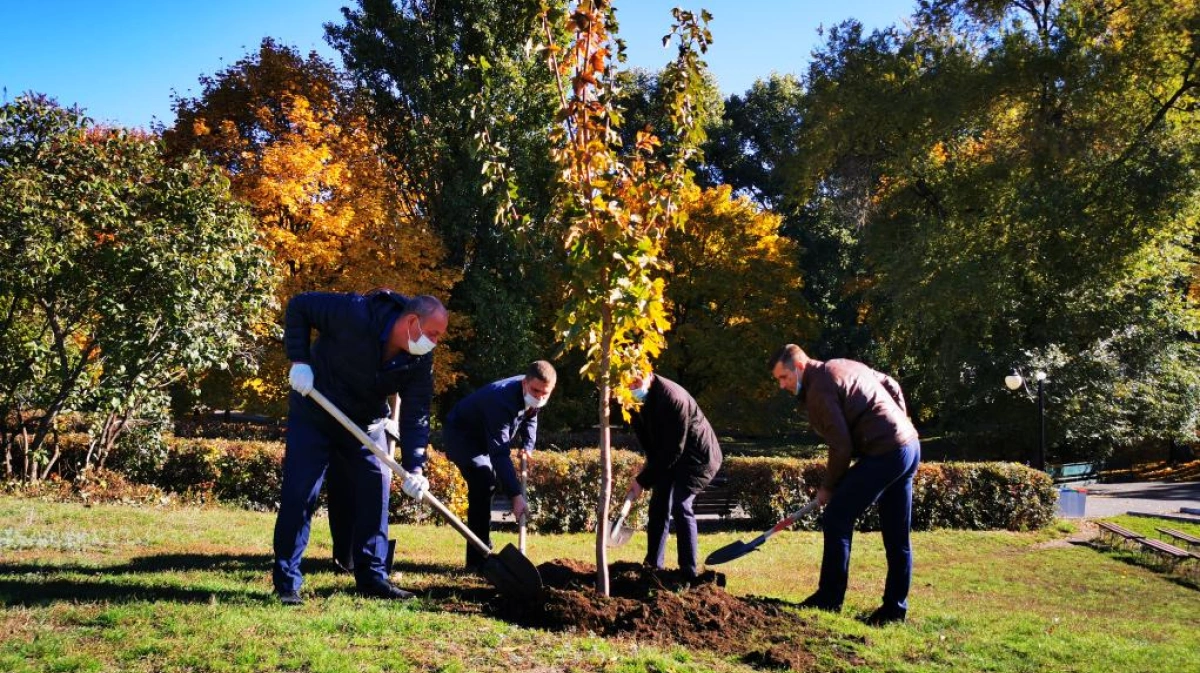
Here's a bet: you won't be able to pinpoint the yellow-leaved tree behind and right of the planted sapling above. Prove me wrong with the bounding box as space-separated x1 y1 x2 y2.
656 185 818 435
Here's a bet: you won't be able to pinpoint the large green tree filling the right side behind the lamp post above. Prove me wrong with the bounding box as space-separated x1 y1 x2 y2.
797 1 1200 457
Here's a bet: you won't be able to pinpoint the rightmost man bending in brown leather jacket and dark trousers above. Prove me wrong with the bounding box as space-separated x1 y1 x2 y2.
770 344 920 625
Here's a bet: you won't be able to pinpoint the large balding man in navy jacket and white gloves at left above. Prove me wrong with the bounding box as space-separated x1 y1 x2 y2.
272 290 449 605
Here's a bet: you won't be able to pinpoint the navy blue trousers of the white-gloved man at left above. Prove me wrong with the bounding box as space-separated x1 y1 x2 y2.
271 392 389 593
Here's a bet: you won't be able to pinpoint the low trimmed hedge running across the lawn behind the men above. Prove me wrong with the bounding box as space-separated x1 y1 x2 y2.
9 438 1057 533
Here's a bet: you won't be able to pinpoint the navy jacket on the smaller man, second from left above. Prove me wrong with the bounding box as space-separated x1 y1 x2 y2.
444 375 538 494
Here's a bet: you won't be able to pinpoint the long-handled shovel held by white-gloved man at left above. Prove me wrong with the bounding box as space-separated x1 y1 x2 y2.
308 389 542 600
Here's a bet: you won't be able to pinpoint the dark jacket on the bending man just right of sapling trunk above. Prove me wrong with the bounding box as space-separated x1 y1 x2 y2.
630 374 721 493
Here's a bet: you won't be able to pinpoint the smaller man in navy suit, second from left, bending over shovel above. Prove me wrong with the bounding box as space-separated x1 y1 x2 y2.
442 360 557 569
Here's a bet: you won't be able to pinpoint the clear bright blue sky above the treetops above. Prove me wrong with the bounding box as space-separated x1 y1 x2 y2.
0 0 916 127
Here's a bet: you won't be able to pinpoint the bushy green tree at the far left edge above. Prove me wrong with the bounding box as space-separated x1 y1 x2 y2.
0 97 272 479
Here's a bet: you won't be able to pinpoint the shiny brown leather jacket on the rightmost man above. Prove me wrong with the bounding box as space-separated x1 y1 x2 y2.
800 360 917 488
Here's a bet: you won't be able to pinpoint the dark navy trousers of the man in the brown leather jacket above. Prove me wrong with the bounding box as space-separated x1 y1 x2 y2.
817 440 920 613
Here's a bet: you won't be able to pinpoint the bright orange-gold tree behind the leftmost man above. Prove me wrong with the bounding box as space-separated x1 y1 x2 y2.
163 38 458 411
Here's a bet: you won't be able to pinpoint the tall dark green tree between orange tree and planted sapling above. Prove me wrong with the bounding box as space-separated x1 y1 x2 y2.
325 0 569 403
